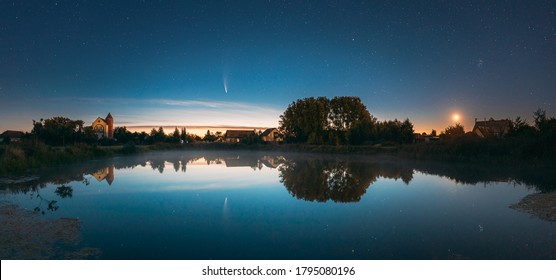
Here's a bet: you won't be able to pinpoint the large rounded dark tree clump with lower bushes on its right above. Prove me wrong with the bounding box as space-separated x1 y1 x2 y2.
280 96 414 145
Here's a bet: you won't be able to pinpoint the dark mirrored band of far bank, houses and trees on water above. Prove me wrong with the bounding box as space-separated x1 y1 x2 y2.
0 151 556 208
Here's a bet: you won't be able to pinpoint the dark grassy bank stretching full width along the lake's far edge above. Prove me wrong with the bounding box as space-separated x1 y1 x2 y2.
0 142 556 176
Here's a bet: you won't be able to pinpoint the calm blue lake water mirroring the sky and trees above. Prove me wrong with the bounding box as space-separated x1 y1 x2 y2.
0 151 556 259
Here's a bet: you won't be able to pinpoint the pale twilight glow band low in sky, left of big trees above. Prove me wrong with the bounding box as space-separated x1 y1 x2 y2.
0 98 282 134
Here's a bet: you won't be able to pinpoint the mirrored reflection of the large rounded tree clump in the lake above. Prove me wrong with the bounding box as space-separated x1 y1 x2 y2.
278 159 413 202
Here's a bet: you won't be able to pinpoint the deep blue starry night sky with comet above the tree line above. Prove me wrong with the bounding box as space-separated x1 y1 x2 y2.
0 0 556 135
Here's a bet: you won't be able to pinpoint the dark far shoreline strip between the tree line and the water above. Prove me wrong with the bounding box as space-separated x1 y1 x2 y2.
0 143 556 177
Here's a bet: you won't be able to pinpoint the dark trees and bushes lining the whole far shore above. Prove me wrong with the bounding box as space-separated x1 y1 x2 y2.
4 99 556 161
